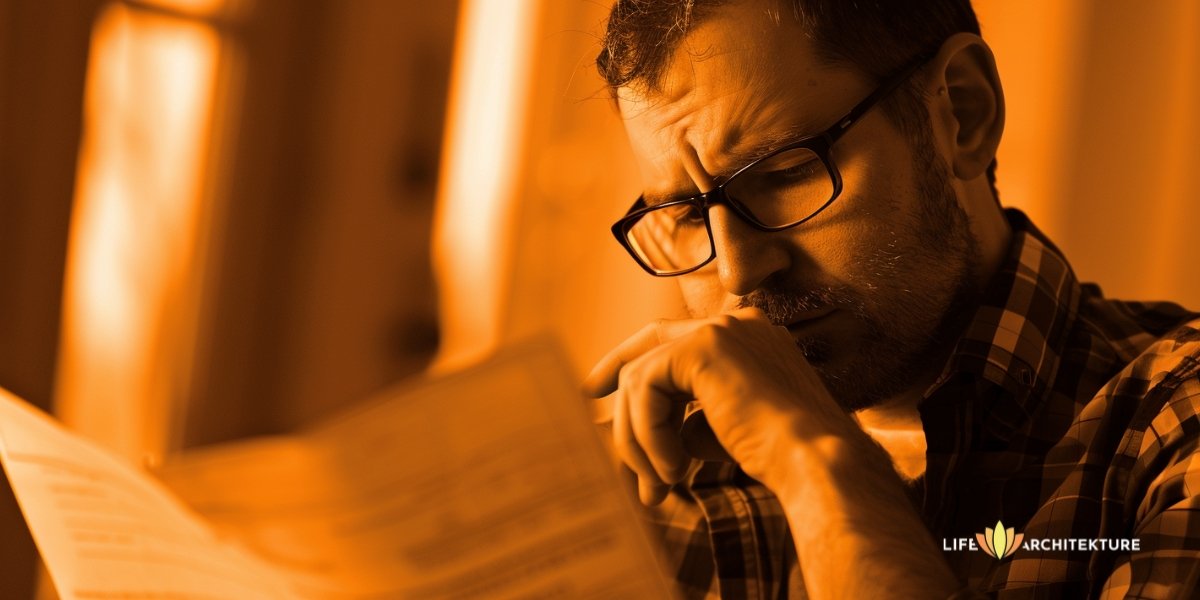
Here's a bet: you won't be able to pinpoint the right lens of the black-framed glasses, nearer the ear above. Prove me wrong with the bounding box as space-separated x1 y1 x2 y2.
725 148 834 227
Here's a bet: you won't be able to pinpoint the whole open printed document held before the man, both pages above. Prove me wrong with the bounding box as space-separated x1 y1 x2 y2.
0 342 673 600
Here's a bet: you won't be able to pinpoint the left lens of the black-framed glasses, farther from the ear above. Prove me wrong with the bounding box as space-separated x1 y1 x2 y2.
625 204 713 274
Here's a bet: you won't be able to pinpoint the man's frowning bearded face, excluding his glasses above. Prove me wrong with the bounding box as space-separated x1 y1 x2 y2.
619 0 979 409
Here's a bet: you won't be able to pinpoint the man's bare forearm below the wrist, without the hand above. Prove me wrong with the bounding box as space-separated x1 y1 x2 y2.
774 436 960 599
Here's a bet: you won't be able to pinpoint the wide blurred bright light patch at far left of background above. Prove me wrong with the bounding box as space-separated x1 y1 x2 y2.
55 4 218 458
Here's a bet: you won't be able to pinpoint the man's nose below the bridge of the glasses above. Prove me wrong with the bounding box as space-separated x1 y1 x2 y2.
708 206 791 295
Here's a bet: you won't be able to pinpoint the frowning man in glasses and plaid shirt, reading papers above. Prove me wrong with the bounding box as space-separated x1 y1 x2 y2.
586 0 1200 598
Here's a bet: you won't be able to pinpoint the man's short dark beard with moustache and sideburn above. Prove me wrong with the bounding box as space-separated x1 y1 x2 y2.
738 136 982 412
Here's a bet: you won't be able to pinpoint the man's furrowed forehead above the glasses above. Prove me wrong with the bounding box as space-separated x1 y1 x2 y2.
619 4 846 203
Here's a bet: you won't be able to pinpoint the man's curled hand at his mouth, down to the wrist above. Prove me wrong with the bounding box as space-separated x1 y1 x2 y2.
584 308 865 504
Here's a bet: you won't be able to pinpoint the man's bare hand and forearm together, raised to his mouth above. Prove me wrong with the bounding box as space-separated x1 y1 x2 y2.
584 308 959 598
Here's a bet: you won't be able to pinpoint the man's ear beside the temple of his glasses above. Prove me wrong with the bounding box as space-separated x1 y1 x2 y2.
926 34 1004 180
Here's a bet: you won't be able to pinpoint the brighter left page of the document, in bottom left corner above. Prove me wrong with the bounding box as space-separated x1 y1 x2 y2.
0 390 304 600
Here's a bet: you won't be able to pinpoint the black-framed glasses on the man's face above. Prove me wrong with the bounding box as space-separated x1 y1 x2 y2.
612 55 929 277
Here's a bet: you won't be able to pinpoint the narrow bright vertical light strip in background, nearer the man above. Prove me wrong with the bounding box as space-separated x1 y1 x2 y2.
433 0 541 367
